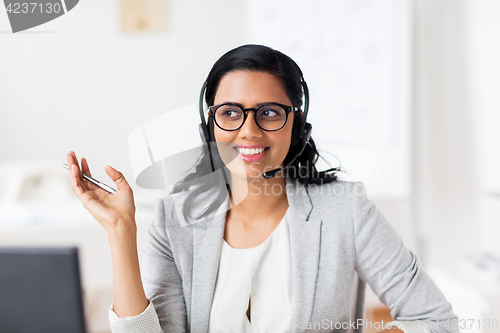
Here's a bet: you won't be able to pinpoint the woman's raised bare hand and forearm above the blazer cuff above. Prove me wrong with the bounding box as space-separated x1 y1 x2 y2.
66 152 149 317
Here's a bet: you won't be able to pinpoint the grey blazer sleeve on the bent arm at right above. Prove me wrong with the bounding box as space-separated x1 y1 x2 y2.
352 182 459 333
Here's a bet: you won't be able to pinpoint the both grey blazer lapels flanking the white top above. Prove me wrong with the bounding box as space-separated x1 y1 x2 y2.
182 178 321 333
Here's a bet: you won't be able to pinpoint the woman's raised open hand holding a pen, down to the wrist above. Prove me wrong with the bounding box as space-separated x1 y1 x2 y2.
66 151 135 233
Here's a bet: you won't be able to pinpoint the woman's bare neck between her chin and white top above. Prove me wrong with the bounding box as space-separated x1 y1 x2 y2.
231 172 288 220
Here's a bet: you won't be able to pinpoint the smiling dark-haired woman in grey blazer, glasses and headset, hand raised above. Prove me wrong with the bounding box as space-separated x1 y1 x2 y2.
64 45 458 333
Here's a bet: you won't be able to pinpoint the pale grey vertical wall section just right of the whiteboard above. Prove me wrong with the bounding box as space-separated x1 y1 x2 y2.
413 0 480 265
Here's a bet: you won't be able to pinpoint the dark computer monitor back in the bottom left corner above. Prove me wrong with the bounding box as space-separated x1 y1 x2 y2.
0 247 85 333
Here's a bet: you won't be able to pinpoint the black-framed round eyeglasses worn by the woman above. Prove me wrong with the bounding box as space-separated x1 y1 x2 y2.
208 102 301 132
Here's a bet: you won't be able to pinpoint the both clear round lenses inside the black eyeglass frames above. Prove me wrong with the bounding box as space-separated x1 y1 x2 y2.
215 104 287 131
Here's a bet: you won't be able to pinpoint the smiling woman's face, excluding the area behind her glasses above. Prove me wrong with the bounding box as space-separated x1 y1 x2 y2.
214 70 293 180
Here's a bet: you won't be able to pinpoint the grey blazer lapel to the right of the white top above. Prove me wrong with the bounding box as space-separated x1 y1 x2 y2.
286 178 321 333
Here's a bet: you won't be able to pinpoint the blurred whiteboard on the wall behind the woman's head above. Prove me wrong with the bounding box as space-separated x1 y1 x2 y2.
246 0 412 197
